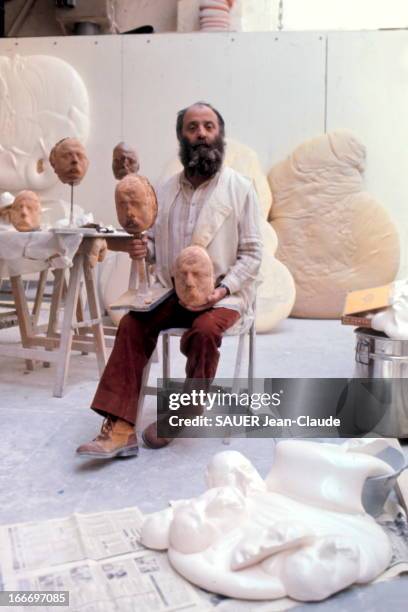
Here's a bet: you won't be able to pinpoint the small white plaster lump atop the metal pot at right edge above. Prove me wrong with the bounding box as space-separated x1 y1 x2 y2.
371 280 408 340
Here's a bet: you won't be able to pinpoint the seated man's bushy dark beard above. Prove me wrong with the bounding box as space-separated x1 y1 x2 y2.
179 136 225 178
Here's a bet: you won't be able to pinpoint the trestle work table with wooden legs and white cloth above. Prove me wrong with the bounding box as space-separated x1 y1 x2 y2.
0 230 127 397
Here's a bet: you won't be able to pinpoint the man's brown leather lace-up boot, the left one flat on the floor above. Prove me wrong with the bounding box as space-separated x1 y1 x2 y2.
76 417 139 459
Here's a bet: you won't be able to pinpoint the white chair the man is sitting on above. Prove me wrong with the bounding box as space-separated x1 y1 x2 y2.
135 303 256 443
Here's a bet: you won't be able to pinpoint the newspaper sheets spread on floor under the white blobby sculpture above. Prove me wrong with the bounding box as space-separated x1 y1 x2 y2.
0 501 408 612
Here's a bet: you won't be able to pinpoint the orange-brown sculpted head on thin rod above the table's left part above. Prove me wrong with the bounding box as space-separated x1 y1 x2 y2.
50 138 89 185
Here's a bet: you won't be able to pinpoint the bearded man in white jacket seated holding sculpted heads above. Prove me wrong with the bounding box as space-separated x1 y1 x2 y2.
77 102 262 459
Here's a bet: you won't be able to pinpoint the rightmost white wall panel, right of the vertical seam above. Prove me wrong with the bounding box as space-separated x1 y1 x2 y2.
327 31 408 276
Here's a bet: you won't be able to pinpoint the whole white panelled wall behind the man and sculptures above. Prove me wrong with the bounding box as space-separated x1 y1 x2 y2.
0 31 408 280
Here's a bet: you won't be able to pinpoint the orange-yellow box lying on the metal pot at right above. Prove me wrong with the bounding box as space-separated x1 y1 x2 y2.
341 283 394 327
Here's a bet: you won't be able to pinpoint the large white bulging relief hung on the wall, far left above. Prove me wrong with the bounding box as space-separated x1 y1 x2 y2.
0 55 90 192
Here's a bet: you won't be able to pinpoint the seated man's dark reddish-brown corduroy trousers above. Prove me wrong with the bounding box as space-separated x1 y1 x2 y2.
91 295 239 425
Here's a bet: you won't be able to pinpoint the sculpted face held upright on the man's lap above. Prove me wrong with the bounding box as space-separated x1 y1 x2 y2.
174 246 215 308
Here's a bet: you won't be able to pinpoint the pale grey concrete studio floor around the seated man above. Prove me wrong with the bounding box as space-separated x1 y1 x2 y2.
0 319 408 611
